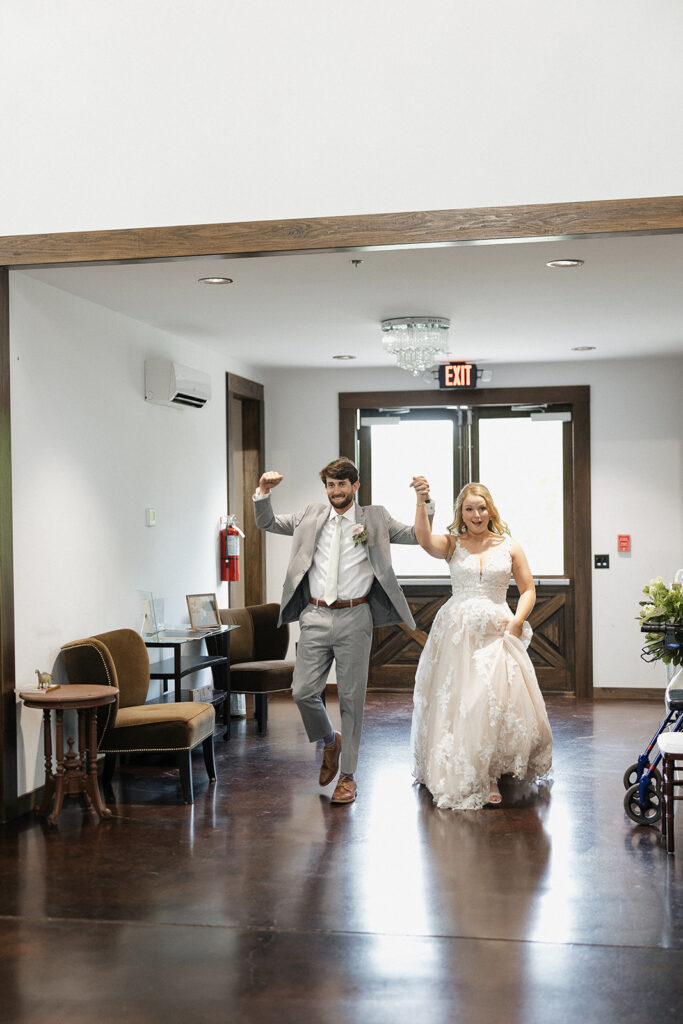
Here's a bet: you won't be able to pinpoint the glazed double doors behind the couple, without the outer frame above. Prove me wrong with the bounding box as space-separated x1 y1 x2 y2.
356 395 575 692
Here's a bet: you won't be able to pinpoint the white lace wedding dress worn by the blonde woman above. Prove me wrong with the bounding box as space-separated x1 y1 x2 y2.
411 538 553 809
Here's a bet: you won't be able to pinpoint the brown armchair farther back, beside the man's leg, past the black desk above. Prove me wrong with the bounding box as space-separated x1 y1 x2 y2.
220 604 294 735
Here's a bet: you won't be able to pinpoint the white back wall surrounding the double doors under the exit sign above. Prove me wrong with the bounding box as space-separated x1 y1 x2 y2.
260 357 683 687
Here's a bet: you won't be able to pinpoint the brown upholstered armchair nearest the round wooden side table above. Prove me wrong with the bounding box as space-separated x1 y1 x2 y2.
61 630 216 804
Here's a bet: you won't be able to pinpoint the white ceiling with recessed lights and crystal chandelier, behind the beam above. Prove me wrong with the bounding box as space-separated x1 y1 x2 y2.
22 234 683 368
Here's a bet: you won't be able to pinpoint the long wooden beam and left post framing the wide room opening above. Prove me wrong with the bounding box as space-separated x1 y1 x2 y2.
0 196 683 821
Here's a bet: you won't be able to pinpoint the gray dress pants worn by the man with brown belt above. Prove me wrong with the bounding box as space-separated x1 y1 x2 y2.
292 604 373 775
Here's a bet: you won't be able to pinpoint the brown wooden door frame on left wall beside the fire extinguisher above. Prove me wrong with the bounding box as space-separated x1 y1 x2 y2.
225 373 265 605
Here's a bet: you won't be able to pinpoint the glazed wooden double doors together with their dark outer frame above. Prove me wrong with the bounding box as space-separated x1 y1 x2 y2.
340 387 593 696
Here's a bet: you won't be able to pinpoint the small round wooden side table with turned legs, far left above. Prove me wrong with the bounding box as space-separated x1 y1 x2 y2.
19 684 119 825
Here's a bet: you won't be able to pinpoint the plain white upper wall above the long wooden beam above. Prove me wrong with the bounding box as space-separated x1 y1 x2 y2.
0 0 683 234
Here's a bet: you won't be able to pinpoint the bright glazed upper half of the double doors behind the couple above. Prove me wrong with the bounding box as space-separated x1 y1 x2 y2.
359 406 570 579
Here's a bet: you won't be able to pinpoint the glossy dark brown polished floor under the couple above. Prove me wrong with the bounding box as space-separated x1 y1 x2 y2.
0 694 683 1024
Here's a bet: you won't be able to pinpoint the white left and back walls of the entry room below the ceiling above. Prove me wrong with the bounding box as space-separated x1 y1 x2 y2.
10 272 683 793
